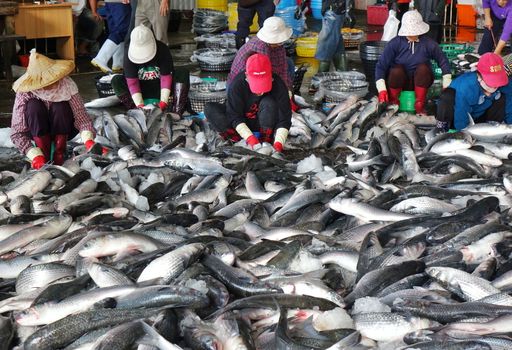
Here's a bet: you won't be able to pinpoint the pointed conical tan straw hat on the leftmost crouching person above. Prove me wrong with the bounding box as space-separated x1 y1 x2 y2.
12 49 75 92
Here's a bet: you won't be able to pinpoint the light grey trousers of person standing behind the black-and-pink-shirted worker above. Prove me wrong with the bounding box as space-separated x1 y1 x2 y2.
135 0 170 45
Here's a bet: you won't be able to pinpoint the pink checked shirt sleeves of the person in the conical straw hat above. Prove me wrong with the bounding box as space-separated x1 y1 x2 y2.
11 85 95 154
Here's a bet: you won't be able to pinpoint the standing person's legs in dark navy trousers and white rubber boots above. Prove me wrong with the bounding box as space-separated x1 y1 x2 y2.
89 0 131 73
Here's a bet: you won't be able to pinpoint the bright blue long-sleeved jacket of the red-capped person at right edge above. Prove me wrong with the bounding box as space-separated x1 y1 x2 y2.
450 72 512 130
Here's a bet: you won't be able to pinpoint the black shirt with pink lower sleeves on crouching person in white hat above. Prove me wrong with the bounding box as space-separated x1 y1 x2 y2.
124 40 174 99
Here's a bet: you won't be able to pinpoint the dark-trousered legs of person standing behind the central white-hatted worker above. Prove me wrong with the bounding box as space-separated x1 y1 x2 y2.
235 0 276 49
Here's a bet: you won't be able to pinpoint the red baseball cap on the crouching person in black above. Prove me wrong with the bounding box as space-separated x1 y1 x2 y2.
245 53 272 94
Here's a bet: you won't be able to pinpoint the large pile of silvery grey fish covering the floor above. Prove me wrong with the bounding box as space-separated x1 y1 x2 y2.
0 97 512 350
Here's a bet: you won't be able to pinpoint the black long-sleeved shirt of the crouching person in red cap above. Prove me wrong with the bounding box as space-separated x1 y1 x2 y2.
226 71 292 131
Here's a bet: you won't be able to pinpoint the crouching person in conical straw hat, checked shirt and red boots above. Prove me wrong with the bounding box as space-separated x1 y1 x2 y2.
11 49 97 169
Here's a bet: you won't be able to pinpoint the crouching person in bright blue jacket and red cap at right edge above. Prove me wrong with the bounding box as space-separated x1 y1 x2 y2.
436 52 512 131
